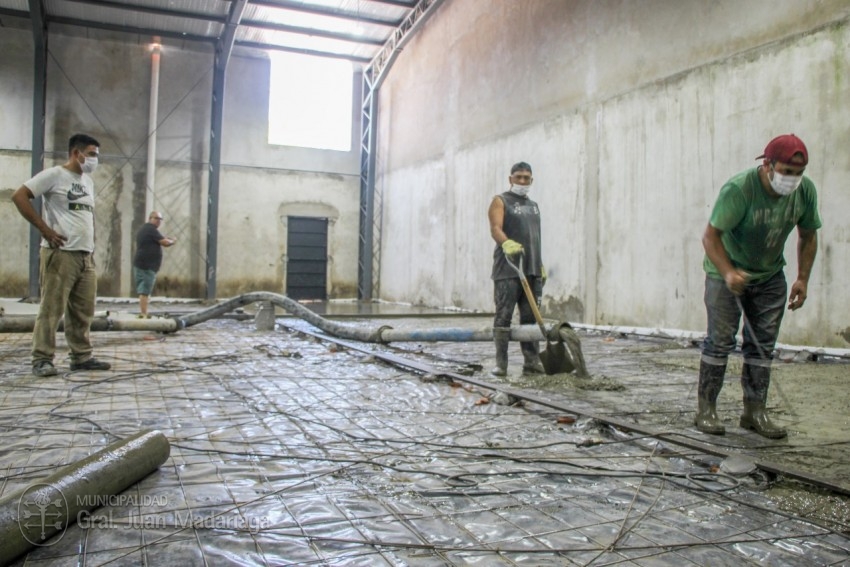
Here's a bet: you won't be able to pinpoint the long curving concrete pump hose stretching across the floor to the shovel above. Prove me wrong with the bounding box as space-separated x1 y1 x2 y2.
0 291 569 343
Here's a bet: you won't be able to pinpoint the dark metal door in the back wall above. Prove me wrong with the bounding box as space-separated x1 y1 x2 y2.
286 217 328 299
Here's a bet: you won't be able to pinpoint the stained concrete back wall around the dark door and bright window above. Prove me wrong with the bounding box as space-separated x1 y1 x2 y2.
0 18 360 298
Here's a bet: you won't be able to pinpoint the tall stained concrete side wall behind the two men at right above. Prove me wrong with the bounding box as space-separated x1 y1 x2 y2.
377 0 850 347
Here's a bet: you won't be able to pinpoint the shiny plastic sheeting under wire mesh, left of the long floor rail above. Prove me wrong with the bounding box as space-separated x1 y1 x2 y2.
0 320 850 566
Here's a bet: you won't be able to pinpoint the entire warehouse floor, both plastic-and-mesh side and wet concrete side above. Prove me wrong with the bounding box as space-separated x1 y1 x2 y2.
0 303 850 566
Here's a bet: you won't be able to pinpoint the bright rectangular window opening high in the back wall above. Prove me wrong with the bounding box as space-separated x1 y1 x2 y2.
269 52 354 152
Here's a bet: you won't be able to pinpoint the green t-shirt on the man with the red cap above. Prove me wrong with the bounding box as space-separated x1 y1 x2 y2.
703 167 821 283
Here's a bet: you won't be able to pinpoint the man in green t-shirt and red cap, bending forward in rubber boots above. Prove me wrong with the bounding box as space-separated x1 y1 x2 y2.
694 134 821 439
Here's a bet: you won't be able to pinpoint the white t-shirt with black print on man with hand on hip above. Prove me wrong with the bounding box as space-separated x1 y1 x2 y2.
24 165 94 252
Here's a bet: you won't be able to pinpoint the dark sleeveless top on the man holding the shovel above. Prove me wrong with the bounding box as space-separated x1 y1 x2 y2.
491 191 543 280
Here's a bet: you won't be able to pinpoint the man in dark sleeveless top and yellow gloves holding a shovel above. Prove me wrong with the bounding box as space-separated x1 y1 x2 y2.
488 162 546 376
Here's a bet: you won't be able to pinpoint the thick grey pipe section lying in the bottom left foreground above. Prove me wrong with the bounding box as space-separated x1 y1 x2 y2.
0 431 171 565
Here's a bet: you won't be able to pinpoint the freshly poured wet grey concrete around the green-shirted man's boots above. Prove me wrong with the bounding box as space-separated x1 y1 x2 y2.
416 332 850 490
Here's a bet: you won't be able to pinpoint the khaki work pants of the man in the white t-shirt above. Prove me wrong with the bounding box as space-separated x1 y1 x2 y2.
32 248 97 366
